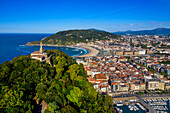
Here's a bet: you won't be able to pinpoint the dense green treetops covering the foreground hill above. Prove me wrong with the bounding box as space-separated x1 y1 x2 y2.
0 50 113 113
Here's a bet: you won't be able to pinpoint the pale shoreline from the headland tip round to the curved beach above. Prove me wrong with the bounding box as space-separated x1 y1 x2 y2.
25 44 99 58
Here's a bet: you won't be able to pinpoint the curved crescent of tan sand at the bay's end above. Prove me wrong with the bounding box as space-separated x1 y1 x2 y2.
77 46 99 57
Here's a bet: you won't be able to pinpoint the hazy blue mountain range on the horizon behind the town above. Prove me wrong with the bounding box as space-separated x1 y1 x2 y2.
114 28 170 35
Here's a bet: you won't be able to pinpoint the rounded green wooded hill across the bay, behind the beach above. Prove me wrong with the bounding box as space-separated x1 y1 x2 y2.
28 30 119 45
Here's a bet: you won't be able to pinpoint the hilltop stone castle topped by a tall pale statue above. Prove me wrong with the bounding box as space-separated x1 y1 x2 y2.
31 42 48 62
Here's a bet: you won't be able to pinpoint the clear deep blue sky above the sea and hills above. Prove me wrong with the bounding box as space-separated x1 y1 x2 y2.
0 0 170 33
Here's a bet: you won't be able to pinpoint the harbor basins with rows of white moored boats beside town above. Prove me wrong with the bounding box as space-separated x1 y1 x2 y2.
114 97 170 113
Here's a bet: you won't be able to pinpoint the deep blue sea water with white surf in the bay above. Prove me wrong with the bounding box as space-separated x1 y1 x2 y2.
0 33 89 64
